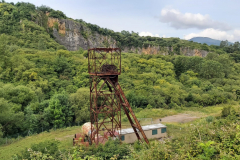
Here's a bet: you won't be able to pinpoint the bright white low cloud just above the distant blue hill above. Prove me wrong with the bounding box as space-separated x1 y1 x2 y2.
184 28 240 42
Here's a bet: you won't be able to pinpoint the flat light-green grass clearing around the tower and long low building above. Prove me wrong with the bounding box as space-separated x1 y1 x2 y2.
0 102 237 160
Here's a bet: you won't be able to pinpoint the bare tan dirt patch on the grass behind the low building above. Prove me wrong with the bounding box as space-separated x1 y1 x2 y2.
154 114 200 123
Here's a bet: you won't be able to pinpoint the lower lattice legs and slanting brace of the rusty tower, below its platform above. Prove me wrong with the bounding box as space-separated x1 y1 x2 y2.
90 75 149 144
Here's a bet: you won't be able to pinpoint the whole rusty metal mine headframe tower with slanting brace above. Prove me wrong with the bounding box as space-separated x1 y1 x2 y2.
88 48 149 144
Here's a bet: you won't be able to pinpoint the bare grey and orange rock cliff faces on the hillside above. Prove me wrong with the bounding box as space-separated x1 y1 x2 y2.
48 18 208 57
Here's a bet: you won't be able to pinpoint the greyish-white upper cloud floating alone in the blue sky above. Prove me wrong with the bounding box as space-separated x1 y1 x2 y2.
160 8 231 30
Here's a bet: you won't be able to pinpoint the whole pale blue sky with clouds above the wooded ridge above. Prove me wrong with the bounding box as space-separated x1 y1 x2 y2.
5 0 240 42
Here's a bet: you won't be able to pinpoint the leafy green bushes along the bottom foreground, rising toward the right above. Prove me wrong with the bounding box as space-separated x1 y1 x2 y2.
14 106 240 160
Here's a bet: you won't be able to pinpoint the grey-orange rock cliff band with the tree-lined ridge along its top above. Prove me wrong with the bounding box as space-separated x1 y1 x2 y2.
48 17 209 57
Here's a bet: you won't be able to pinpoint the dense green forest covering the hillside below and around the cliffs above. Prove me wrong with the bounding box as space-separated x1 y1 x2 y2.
0 2 240 158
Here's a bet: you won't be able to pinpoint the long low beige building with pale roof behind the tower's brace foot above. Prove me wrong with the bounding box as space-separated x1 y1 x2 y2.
120 123 167 143
